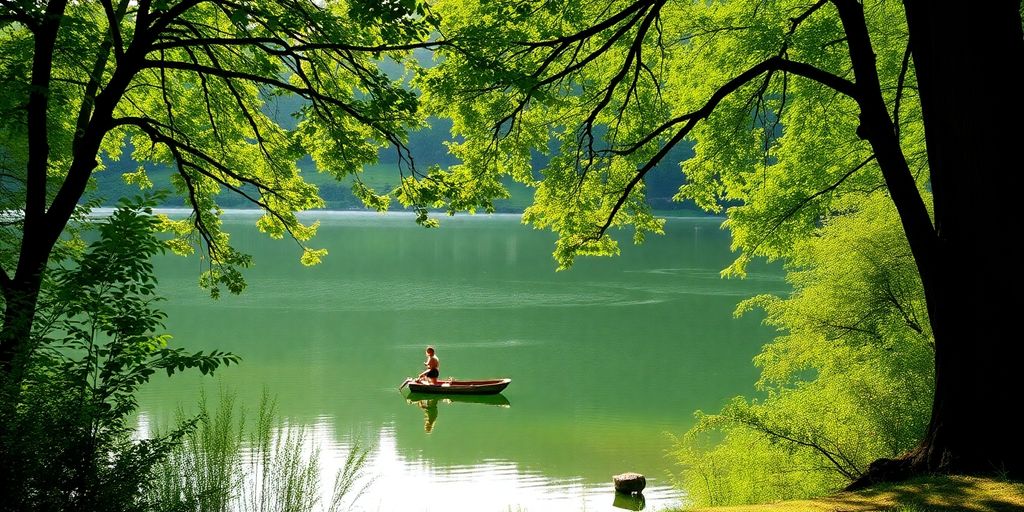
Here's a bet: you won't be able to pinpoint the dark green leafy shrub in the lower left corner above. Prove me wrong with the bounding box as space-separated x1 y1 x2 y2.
0 200 239 510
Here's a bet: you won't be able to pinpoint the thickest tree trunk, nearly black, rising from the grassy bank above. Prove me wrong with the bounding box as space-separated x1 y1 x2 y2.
905 0 1024 477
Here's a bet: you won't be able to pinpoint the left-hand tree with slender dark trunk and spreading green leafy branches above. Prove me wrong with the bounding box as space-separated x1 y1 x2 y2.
0 0 435 387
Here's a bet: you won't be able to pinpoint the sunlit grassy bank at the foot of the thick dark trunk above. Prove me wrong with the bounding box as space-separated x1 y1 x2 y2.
688 476 1024 512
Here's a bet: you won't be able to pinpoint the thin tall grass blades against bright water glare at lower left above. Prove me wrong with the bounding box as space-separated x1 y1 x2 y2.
150 391 370 512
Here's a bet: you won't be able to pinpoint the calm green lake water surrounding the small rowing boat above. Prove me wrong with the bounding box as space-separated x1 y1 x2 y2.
139 209 785 512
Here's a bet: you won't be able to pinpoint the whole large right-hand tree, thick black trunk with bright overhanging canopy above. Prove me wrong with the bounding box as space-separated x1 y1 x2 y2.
409 0 1024 483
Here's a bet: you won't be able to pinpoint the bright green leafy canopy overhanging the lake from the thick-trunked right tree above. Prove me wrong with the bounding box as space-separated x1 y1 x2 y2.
421 0 927 273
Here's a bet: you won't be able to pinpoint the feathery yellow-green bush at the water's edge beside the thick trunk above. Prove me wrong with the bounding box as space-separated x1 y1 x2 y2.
677 193 934 505
